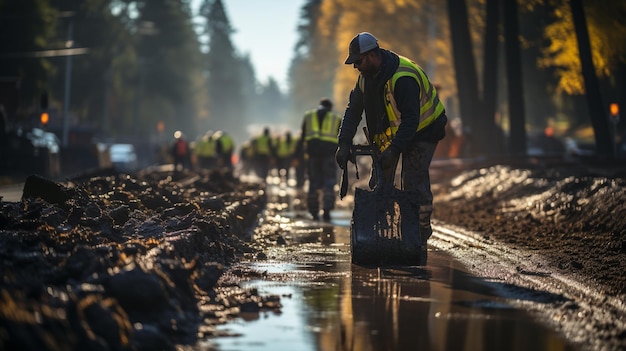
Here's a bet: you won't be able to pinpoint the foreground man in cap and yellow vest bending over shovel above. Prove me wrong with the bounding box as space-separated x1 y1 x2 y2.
336 32 448 253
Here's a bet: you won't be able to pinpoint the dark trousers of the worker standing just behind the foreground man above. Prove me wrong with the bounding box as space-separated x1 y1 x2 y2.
307 155 337 214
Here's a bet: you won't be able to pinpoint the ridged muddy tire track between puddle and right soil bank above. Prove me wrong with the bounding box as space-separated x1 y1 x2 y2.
429 221 626 350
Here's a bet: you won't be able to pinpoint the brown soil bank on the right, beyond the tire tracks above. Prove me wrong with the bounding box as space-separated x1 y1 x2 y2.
433 165 626 298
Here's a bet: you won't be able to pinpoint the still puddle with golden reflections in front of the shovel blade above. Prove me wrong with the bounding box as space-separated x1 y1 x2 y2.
213 252 571 351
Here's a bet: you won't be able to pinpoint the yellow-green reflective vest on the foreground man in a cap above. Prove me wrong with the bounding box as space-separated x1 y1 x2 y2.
359 56 444 151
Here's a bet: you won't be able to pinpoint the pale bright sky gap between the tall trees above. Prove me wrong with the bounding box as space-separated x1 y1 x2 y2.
192 0 305 92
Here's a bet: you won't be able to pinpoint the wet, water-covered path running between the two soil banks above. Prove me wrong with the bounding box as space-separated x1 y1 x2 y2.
200 179 584 351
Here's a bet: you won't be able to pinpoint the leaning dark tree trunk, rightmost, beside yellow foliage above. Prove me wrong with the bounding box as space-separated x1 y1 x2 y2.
570 0 615 159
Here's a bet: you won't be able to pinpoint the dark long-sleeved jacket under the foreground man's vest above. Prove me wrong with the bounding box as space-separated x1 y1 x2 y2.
338 49 448 151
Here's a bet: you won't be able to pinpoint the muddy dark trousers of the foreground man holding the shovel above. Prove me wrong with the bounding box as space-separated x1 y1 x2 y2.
383 141 437 243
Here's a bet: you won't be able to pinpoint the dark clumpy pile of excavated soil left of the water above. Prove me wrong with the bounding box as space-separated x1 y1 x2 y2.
0 171 280 350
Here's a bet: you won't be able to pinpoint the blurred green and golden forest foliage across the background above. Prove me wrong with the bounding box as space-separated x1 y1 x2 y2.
0 0 626 158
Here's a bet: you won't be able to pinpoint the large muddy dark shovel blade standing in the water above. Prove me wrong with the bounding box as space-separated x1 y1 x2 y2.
350 184 422 265
